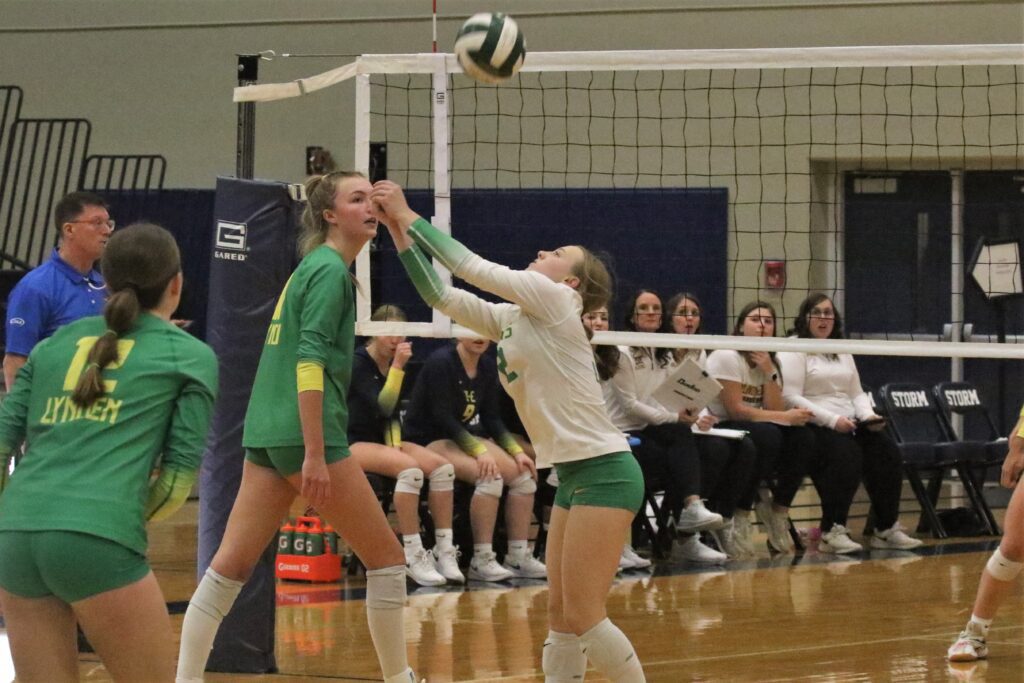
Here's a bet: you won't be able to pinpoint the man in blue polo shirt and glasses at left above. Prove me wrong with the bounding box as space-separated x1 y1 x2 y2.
3 193 114 391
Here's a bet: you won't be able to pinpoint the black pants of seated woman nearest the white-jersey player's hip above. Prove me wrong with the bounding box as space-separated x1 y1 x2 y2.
631 423 700 517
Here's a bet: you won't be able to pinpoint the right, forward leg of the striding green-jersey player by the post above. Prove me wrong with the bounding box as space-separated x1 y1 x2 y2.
299 458 415 683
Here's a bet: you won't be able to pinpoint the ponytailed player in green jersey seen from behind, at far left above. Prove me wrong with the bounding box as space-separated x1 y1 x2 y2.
0 224 217 681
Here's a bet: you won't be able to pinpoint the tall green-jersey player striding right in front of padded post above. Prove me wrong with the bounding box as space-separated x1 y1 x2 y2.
177 173 415 683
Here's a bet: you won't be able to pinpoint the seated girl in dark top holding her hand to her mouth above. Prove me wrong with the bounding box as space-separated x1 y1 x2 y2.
348 304 466 586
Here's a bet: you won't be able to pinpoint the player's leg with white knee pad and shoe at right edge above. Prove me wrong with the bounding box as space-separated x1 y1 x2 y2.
948 483 1024 661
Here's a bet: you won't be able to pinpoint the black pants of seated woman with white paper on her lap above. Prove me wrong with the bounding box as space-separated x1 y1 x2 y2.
694 435 758 518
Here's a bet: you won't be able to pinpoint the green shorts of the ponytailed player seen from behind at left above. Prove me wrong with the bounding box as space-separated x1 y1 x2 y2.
0 531 150 603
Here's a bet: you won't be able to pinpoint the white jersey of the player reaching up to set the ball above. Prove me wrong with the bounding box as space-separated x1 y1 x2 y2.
437 254 630 467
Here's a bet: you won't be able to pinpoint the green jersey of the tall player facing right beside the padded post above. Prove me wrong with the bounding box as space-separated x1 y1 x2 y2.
242 246 355 454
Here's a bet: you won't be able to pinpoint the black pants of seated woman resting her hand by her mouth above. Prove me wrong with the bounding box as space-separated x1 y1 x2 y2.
722 420 814 510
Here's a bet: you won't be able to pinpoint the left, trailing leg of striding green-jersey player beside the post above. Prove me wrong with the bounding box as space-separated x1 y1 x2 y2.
177 458 301 682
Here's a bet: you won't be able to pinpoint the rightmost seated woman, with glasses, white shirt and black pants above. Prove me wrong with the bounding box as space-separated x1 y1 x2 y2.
778 294 921 553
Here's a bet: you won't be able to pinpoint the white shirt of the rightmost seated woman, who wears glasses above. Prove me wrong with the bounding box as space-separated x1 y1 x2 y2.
777 351 874 429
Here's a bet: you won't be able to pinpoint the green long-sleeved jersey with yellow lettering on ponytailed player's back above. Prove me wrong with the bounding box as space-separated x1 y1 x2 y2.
0 313 217 561
